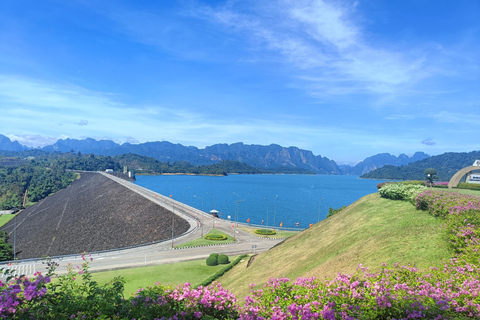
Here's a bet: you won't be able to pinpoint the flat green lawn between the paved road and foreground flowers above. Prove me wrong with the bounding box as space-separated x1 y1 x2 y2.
86 256 237 297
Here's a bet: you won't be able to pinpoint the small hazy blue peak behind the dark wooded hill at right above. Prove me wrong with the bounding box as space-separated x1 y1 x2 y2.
341 152 430 176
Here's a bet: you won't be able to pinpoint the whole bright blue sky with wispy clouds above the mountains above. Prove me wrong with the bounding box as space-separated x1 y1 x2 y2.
0 0 480 163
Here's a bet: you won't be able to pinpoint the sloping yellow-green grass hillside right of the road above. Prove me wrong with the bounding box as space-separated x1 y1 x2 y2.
218 194 450 296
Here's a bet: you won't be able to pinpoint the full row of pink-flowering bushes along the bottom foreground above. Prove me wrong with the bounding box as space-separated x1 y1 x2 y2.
0 259 480 320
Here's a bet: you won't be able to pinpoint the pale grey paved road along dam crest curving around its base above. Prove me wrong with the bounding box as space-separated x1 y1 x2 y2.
0 173 281 275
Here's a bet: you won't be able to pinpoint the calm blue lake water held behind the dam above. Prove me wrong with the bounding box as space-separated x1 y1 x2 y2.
136 174 383 229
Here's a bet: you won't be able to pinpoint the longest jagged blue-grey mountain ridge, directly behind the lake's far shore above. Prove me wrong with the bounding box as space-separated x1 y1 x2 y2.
43 138 340 174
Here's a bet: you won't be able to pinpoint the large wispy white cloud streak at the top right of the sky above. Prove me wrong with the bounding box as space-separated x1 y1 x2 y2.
199 0 426 94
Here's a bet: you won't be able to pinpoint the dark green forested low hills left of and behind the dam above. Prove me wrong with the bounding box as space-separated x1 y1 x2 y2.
0 150 274 210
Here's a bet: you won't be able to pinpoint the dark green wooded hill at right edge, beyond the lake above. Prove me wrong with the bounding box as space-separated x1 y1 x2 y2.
361 151 480 181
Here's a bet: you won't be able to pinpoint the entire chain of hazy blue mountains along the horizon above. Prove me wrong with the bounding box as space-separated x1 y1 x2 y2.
0 135 434 175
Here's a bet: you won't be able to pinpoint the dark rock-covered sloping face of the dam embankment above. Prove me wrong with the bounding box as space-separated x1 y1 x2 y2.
1 172 191 259
